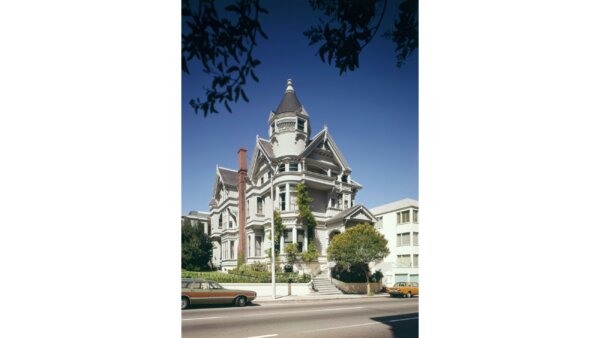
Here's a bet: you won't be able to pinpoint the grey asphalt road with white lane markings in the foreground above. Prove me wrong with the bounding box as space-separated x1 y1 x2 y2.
181 297 419 338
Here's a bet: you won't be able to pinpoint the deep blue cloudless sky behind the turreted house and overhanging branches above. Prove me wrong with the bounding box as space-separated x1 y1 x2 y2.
181 1 419 214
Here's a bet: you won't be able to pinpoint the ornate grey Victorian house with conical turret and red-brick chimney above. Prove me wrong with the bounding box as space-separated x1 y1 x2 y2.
209 80 376 270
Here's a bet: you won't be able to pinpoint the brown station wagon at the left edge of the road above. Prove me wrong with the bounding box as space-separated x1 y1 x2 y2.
181 278 256 309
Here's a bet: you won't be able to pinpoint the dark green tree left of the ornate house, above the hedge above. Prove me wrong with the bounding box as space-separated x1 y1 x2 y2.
181 219 213 271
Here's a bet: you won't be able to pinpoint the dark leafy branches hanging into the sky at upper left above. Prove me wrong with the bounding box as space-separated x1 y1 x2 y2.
181 0 268 117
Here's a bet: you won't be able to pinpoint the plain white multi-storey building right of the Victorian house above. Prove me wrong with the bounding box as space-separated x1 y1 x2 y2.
370 198 419 286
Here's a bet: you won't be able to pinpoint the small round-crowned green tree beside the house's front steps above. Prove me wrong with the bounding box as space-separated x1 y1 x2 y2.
327 223 390 295
